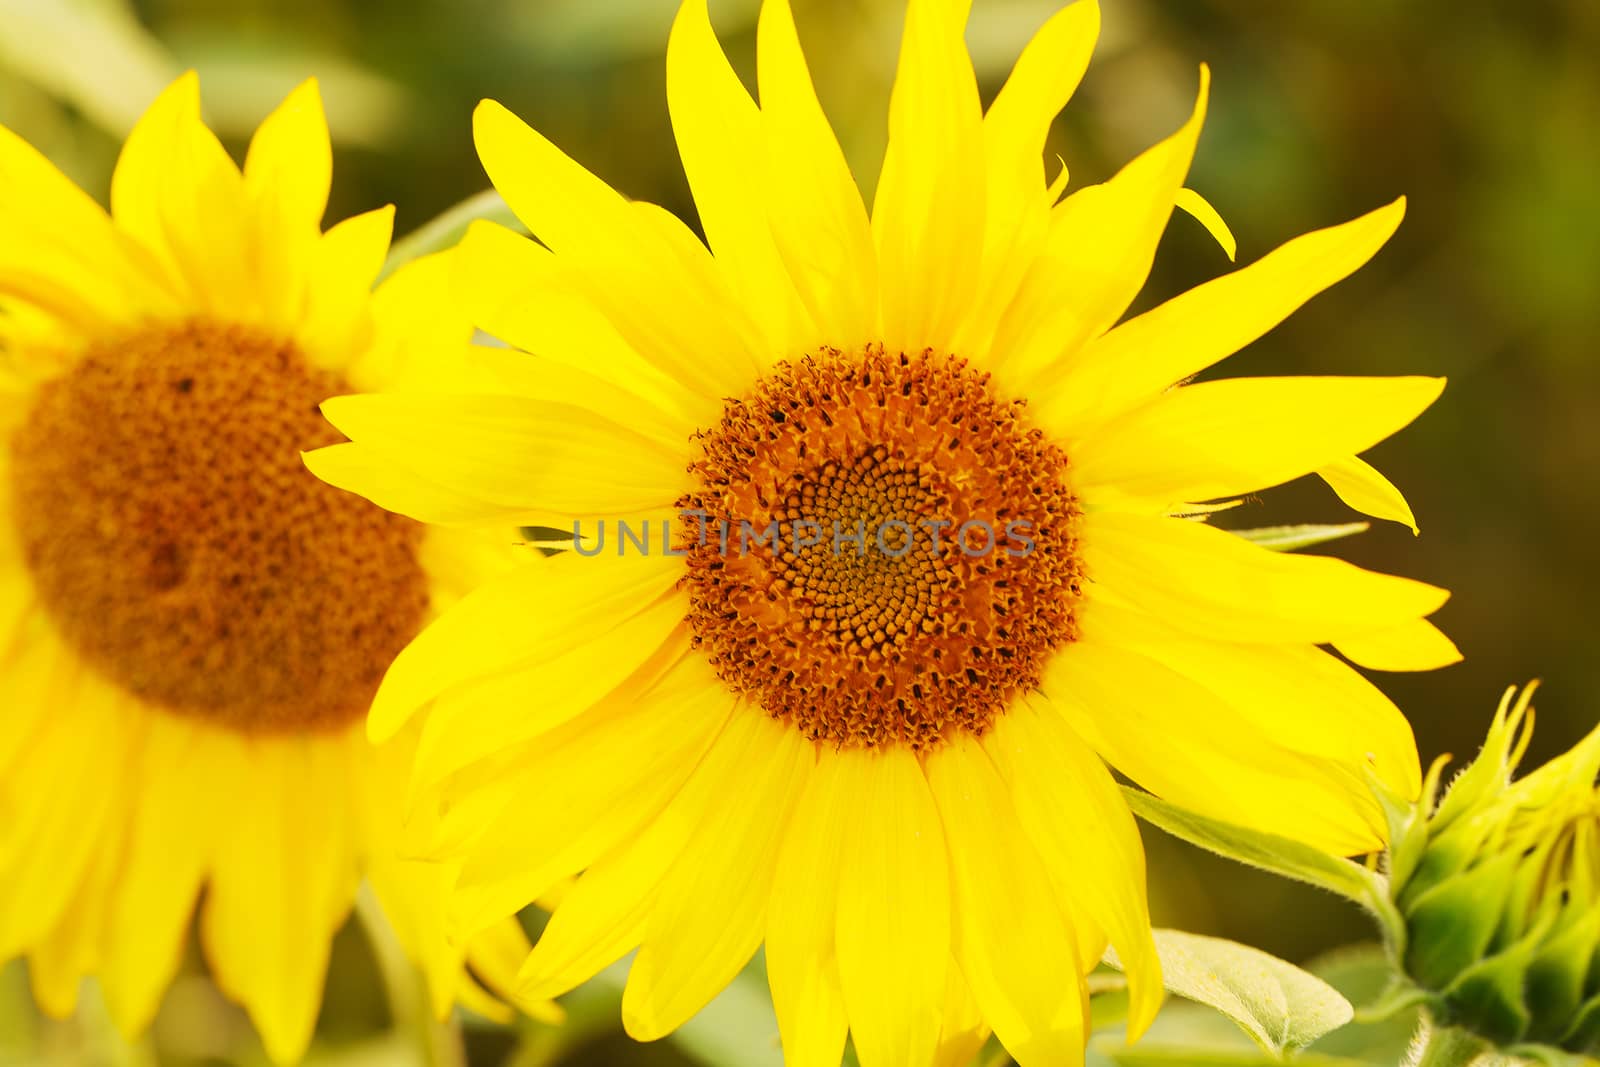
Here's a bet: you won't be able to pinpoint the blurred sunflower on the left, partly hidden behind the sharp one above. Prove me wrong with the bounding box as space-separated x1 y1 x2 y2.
0 75 550 1061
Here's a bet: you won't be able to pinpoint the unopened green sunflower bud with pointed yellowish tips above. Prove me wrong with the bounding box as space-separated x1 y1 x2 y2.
1387 685 1600 1057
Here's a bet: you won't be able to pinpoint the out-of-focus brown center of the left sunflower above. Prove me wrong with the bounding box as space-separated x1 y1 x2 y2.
11 322 427 731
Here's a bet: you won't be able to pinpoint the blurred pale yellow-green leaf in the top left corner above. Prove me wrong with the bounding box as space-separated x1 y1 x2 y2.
0 0 179 138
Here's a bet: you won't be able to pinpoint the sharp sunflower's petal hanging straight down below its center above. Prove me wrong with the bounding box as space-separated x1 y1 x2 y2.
835 747 950 1067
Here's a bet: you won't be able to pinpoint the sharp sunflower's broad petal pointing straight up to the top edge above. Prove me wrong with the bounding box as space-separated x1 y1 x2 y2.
872 0 984 352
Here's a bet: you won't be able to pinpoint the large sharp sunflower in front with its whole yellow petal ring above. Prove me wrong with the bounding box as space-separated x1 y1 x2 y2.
307 0 1456 1067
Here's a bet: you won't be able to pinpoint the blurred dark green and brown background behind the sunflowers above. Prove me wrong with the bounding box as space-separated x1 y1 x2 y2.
0 0 1600 1067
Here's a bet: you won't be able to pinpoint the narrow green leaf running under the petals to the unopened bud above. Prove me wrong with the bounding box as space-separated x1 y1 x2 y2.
1122 785 1403 933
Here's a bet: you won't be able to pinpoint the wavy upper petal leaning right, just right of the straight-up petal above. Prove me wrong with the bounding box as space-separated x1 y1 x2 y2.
957 0 1101 352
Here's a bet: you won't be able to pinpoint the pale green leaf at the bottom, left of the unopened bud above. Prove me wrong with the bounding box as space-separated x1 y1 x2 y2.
1106 929 1354 1056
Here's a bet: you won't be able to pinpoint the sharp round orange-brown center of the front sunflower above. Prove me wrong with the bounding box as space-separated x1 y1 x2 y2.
678 347 1080 750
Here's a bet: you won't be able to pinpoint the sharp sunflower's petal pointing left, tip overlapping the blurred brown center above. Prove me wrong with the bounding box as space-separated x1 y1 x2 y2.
322 394 688 520
